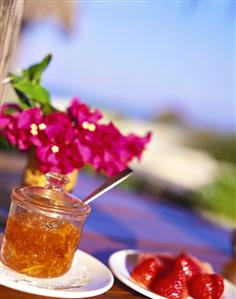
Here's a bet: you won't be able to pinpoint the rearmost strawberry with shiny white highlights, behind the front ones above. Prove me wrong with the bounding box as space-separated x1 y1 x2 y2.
174 253 201 281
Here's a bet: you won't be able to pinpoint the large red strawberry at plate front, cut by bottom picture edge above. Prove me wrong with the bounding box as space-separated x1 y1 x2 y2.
151 269 188 299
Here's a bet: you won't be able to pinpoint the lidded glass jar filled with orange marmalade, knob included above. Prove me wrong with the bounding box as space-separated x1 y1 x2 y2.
1 173 90 278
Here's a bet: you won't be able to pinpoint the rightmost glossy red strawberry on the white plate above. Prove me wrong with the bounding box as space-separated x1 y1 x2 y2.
188 274 224 299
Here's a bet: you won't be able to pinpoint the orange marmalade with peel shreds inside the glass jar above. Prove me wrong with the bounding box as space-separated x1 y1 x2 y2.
1 211 82 278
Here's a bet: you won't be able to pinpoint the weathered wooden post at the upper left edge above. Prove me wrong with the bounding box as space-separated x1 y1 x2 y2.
0 0 24 103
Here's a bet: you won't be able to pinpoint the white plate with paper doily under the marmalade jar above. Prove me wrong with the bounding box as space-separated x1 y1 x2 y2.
0 250 114 298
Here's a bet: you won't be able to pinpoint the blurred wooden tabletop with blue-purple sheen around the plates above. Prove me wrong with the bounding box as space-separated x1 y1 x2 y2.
0 152 231 299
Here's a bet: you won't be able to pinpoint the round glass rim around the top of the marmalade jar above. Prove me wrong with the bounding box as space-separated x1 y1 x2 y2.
11 187 91 217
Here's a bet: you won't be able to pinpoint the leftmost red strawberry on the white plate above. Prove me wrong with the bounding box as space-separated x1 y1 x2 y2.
131 258 159 288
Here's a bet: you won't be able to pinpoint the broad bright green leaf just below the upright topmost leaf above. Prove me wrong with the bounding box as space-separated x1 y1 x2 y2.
14 82 50 105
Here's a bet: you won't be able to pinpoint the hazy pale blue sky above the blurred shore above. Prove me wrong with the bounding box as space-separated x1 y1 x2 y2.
16 0 236 130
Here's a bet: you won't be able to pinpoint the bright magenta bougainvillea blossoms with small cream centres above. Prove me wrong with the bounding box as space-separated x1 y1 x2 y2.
0 99 151 176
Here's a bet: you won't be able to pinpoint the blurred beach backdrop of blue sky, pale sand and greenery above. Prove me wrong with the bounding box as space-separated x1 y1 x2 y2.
1 0 236 227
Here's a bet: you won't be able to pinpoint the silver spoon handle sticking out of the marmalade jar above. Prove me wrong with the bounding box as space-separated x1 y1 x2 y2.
82 168 133 204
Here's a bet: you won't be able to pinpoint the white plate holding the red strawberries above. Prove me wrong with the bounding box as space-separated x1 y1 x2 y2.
109 249 236 299
